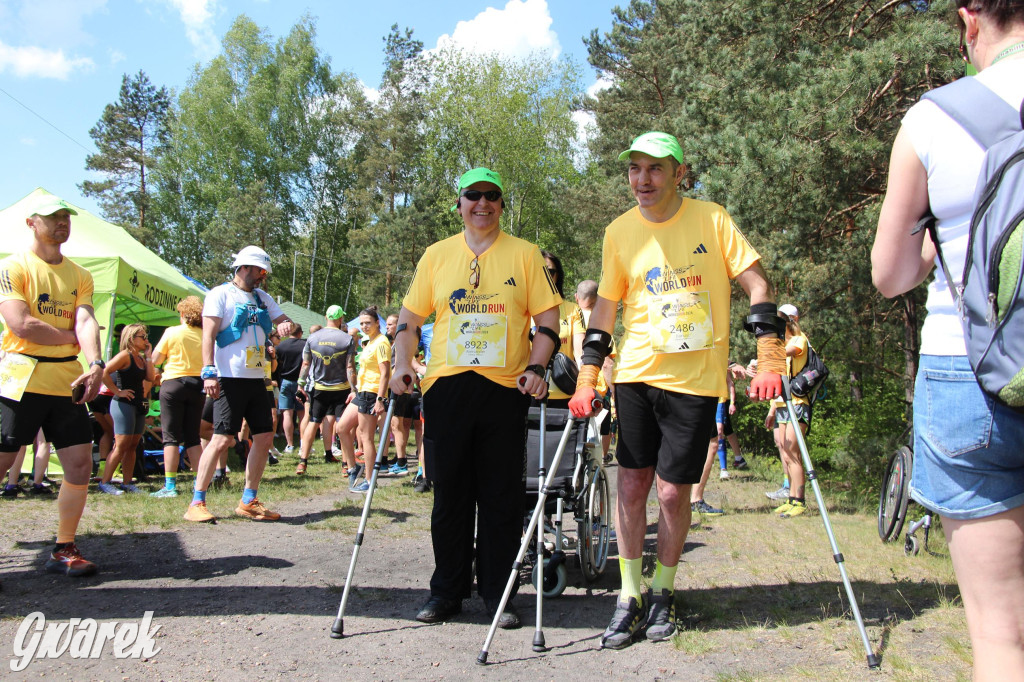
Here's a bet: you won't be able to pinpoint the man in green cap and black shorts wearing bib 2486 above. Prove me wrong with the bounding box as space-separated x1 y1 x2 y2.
569 132 785 649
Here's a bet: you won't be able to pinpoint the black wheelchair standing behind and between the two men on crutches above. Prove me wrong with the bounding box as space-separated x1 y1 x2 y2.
523 407 612 597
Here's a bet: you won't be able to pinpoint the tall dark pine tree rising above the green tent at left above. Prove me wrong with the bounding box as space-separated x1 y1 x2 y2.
79 71 171 246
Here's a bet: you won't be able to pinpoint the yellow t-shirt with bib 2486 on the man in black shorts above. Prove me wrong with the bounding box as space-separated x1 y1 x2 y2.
598 199 760 397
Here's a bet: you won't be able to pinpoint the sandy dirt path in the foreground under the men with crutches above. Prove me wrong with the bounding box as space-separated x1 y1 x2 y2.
0 462 958 680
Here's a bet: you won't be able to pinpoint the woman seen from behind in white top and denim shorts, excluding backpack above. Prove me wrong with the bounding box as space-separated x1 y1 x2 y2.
871 0 1024 680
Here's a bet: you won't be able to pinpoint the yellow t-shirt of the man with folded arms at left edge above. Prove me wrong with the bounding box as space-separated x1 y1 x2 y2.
0 251 93 396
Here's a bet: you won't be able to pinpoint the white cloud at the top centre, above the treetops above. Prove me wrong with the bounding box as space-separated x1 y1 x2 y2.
436 0 562 59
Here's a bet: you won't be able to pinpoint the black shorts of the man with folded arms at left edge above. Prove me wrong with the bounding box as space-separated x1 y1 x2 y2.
0 393 92 453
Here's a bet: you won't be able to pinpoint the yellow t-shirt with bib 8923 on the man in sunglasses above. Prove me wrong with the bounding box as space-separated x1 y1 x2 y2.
402 232 562 393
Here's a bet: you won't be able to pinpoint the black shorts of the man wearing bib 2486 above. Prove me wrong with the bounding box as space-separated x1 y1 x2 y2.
615 383 718 484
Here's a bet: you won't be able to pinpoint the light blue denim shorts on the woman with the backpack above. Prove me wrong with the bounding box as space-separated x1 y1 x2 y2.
910 355 1024 519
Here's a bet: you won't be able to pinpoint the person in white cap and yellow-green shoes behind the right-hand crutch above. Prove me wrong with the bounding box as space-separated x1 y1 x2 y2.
765 303 811 518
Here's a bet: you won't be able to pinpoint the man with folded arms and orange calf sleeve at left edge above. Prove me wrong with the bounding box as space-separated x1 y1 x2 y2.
0 195 103 577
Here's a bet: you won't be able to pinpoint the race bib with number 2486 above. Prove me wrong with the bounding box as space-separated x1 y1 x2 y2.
647 291 715 353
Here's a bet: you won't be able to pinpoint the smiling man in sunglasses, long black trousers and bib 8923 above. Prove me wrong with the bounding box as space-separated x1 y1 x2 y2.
391 168 561 628
